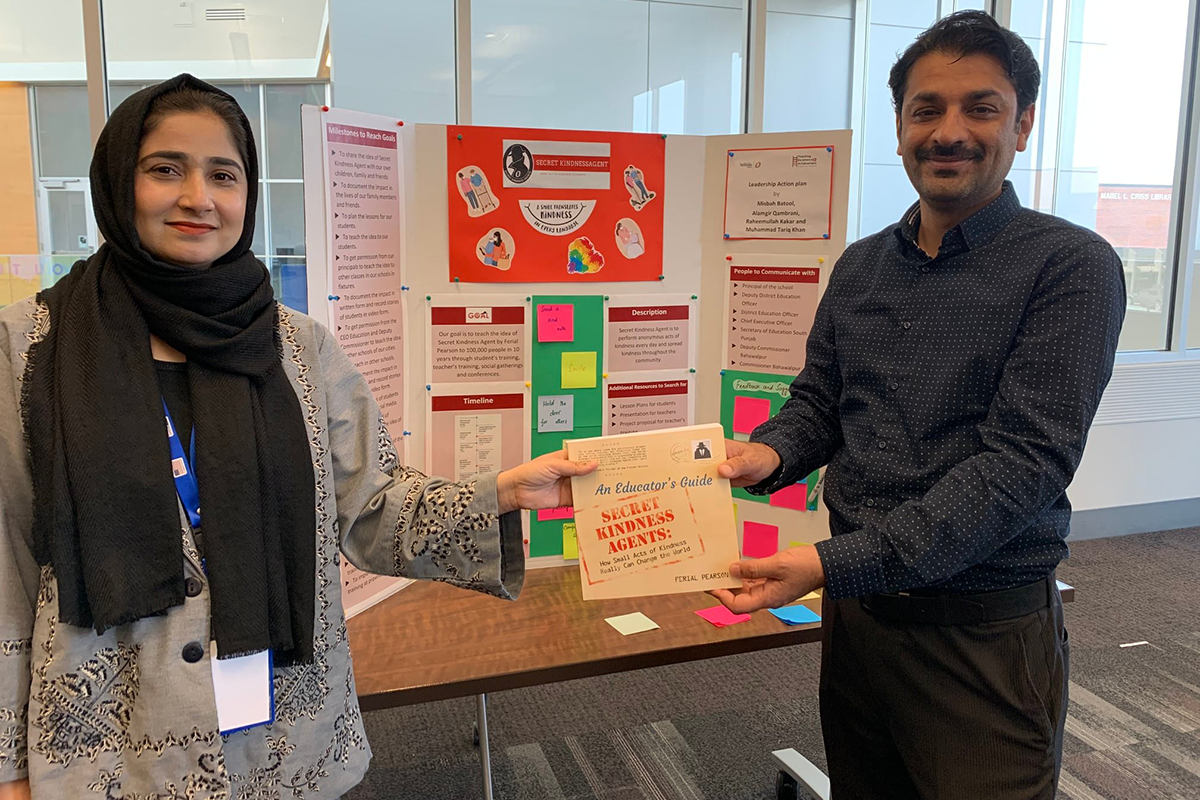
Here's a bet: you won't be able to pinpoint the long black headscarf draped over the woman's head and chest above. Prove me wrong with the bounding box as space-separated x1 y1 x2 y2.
23 74 317 664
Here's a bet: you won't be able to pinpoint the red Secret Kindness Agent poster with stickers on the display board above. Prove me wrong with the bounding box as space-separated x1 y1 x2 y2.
446 125 666 283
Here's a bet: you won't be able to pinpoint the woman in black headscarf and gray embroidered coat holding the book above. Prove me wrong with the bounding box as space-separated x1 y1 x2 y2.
0 76 590 800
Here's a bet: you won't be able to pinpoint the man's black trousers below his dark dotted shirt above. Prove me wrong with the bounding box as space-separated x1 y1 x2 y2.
821 591 1069 800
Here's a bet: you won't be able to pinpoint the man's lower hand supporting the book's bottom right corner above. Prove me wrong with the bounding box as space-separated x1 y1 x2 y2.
708 545 824 614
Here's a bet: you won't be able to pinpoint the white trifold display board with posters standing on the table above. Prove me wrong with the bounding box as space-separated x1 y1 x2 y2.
302 107 850 582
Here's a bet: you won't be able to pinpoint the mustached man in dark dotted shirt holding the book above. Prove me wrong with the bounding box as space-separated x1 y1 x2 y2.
714 12 1124 800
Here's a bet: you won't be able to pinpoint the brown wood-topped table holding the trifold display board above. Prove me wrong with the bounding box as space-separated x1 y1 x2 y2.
347 566 1074 800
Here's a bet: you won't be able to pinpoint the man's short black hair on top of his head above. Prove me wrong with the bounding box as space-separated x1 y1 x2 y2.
888 11 1042 116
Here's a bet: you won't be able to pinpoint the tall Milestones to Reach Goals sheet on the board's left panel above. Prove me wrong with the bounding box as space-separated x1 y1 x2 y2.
320 109 410 616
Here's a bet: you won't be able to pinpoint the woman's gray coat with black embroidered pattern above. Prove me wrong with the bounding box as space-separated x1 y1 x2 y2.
0 300 524 800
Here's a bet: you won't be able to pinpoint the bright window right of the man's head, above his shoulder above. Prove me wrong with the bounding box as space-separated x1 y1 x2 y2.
1012 0 1188 350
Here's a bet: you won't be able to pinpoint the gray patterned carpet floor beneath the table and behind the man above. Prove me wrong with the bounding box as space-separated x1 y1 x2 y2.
346 528 1200 800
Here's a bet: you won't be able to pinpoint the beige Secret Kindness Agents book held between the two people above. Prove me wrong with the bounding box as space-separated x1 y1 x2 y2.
566 425 742 600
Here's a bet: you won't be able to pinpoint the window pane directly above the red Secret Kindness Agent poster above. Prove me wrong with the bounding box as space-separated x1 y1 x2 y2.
470 0 744 133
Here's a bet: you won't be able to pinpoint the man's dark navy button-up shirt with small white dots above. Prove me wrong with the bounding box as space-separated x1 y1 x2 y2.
750 181 1126 599
